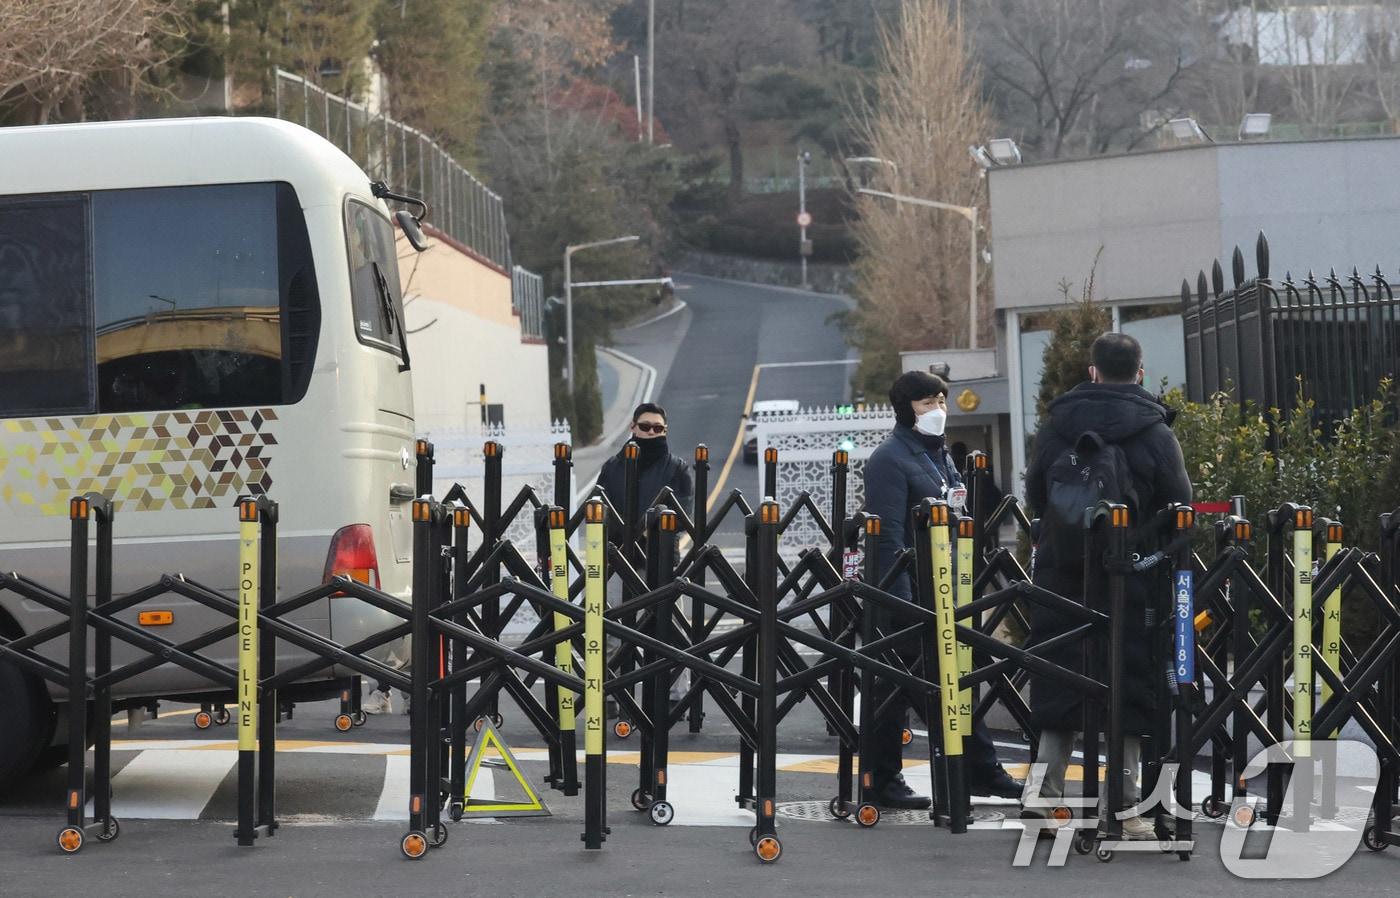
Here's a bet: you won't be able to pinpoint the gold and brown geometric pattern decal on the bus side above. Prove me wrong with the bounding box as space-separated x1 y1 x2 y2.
0 409 277 516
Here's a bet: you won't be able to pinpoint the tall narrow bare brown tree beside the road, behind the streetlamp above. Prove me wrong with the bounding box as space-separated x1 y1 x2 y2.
851 0 990 384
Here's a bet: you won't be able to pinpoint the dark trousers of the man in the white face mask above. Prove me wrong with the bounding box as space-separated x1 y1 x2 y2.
861 602 1001 787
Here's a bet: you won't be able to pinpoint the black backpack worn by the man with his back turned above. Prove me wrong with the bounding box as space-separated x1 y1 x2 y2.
1040 430 1138 570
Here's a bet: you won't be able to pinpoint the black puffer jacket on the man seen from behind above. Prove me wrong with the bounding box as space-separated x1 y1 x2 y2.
1026 384 1191 735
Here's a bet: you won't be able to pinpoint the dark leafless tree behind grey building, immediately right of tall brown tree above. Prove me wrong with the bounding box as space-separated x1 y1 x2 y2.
963 0 1196 158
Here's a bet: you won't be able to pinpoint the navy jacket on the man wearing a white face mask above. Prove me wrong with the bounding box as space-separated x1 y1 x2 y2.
865 424 963 600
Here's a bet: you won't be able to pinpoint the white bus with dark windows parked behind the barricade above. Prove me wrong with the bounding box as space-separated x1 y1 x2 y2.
0 118 421 786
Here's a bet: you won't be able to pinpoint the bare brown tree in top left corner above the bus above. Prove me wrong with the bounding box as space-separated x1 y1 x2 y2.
0 0 189 125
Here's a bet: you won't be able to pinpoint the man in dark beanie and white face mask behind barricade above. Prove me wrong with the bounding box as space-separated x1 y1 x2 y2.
861 371 1022 810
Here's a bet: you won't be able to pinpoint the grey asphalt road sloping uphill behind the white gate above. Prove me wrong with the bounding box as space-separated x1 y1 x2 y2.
613 275 854 548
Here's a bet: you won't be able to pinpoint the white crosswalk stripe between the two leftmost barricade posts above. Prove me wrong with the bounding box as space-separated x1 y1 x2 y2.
95 750 238 820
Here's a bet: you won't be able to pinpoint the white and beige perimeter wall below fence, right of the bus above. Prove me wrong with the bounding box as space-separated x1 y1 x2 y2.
399 233 550 434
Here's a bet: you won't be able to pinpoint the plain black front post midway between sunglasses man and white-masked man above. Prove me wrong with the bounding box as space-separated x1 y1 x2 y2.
753 498 783 863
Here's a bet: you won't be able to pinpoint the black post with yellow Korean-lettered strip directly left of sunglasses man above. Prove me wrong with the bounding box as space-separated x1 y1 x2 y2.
582 499 608 849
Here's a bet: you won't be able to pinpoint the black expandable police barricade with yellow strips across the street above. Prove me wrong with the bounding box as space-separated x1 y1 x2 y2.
8 443 1400 862
